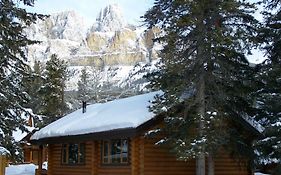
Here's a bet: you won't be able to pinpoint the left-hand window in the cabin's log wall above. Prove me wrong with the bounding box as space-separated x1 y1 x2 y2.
61 143 85 164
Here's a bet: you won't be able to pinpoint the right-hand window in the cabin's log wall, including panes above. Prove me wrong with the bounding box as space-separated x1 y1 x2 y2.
102 139 128 164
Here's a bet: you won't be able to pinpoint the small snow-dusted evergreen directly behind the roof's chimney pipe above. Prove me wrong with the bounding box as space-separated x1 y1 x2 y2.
77 67 91 102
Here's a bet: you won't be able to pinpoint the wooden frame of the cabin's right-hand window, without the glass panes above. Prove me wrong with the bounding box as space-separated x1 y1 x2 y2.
101 138 130 166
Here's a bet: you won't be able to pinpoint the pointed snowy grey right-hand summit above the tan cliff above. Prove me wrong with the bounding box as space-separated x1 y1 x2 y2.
94 4 126 32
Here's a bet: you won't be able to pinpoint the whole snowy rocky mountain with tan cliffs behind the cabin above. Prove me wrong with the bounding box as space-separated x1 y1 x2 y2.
26 5 161 94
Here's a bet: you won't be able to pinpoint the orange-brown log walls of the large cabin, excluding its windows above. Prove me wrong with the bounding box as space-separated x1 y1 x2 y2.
48 136 251 175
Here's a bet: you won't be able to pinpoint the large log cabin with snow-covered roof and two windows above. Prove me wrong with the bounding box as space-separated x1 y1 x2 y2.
31 92 262 175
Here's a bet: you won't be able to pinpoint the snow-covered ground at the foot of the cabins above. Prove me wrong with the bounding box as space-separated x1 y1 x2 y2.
3 164 267 175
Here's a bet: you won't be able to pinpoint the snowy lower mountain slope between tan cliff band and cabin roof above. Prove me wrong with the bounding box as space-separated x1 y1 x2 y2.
66 60 158 91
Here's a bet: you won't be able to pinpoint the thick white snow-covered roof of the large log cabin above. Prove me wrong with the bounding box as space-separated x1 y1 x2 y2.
31 91 160 140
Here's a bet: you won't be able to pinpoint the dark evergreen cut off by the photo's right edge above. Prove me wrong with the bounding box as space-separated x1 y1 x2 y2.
253 0 281 174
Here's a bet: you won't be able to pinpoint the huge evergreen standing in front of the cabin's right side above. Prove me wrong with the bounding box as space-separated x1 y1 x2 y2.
144 0 258 175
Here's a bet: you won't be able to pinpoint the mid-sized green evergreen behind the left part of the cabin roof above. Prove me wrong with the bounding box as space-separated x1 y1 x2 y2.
40 54 67 125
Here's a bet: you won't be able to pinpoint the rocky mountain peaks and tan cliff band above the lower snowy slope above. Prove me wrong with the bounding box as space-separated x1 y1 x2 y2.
26 5 159 66
